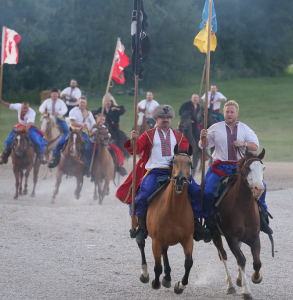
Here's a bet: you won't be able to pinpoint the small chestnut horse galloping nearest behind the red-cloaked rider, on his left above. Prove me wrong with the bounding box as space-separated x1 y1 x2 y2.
91 127 115 204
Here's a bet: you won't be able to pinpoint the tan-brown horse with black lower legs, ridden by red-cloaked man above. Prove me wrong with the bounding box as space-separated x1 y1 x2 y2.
139 145 194 294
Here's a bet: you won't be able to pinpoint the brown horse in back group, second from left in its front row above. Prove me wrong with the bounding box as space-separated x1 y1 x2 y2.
51 128 86 204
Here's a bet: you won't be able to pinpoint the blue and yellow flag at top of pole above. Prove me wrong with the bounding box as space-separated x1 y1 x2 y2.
193 0 217 53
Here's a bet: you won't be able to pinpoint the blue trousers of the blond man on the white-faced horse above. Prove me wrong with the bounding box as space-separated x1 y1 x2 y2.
202 164 268 218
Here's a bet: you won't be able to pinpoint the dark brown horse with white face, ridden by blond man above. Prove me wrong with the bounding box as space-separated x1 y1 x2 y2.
213 149 265 299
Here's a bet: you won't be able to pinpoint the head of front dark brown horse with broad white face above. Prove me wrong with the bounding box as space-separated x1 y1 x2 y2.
239 149 265 199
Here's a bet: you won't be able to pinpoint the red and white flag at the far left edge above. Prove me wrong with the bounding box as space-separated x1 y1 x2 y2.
1 27 21 65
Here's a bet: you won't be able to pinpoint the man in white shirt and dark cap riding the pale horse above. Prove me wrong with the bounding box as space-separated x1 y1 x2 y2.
39 89 69 134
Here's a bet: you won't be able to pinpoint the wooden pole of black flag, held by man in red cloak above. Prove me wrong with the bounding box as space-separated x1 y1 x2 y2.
131 0 141 233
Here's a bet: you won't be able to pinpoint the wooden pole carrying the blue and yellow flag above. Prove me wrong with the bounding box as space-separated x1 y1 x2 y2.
200 0 212 219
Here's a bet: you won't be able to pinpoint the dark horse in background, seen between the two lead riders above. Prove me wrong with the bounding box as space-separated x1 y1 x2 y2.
179 111 202 176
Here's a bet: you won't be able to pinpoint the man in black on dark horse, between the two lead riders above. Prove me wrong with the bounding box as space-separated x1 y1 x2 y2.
179 94 204 141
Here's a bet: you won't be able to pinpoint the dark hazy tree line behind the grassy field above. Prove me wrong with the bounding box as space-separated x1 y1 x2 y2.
0 0 293 91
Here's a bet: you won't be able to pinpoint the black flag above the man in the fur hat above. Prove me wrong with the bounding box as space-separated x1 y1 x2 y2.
131 0 151 79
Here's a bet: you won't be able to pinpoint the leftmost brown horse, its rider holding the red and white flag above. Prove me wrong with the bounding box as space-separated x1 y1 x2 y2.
11 126 41 199
